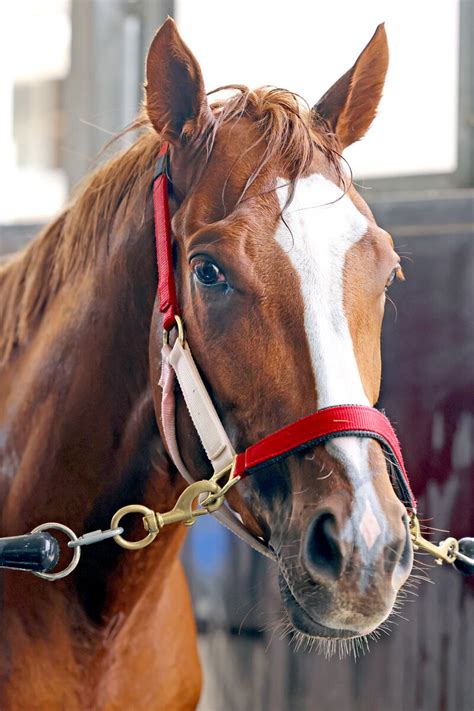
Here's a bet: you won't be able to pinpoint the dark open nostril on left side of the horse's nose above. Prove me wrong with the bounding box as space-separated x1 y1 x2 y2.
304 511 343 580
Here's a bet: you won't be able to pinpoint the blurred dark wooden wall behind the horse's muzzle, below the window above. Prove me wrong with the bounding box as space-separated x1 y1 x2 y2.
184 191 474 711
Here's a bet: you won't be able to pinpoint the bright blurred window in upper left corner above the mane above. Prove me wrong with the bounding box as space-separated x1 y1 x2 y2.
0 0 71 223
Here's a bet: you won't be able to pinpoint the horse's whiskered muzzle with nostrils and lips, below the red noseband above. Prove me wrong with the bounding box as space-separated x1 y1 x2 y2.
278 492 413 638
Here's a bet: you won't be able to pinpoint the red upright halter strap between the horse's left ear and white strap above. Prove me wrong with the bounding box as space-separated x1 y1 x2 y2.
153 143 179 331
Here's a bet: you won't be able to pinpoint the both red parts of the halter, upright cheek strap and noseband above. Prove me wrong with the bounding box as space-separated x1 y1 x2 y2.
153 144 416 512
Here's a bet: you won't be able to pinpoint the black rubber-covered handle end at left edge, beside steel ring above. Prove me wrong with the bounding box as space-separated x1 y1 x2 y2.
0 533 59 573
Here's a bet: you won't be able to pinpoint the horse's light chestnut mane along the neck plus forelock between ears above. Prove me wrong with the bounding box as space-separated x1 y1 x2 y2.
0 85 342 364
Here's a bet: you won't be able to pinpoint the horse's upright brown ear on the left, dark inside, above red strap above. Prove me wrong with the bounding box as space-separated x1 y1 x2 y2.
145 17 212 145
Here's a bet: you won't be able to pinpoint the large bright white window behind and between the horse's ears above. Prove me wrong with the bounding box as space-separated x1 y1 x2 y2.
176 0 459 176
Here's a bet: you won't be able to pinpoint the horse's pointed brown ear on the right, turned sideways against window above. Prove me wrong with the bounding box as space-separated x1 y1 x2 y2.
313 24 388 149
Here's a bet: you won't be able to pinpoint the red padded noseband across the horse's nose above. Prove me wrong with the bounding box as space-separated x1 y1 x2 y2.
233 405 416 510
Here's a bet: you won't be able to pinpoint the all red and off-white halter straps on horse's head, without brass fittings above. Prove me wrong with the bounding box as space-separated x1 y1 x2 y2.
153 144 416 558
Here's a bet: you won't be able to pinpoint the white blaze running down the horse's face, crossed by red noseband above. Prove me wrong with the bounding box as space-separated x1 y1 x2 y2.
276 174 380 544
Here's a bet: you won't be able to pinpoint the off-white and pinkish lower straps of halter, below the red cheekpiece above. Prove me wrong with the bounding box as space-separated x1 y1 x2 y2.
160 344 275 560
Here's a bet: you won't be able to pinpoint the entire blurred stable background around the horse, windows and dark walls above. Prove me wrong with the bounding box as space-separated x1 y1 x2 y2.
0 0 474 711
